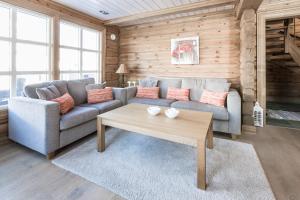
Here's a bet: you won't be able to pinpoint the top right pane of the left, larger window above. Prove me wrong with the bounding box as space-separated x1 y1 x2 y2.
17 11 49 43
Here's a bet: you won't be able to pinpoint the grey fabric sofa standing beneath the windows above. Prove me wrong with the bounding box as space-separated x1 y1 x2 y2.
8 78 126 157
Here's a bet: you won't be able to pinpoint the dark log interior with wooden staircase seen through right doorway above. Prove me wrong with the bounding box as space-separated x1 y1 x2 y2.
266 18 300 102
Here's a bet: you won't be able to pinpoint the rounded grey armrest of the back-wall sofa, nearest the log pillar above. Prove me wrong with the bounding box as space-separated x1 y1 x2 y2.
227 89 242 135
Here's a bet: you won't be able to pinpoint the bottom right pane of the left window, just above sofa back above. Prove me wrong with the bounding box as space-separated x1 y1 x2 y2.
16 74 48 96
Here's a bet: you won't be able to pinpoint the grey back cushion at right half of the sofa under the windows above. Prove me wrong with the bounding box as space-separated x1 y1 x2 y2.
67 78 95 106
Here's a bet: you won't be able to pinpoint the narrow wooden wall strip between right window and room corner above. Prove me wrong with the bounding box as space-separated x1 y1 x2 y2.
105 26 120 86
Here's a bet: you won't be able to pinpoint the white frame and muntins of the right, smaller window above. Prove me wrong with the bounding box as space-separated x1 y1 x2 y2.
58 19 103 82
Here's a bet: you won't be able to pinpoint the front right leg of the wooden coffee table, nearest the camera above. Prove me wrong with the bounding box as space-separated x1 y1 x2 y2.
197 140 206 190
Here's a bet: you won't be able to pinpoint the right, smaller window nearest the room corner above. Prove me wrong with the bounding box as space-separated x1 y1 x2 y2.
59 21 101 82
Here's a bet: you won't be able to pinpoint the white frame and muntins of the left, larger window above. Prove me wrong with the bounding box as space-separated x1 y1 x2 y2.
0 2 53 98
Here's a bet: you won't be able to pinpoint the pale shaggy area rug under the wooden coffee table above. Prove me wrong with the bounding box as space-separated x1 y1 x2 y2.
52 129 275 200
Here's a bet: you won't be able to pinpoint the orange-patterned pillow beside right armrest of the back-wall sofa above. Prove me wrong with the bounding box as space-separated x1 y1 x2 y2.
200 90 228 107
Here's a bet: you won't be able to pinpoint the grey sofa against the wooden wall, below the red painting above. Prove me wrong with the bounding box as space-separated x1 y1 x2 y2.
127 78 241 138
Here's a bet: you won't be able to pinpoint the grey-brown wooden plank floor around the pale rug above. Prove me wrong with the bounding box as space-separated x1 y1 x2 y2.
0 127 300 200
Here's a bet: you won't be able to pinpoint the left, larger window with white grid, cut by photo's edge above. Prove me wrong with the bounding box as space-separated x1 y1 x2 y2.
0 4 51 105
